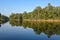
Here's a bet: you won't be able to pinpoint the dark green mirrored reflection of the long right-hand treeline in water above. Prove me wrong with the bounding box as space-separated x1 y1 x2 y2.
10 21 60 38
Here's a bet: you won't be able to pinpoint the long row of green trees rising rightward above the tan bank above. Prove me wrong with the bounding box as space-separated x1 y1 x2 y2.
10 3 60 20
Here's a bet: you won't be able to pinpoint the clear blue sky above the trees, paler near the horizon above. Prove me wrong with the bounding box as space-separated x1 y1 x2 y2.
0 0 60 16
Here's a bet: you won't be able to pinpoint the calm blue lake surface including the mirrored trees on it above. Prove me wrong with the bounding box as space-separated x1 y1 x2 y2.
0 21 60 40
